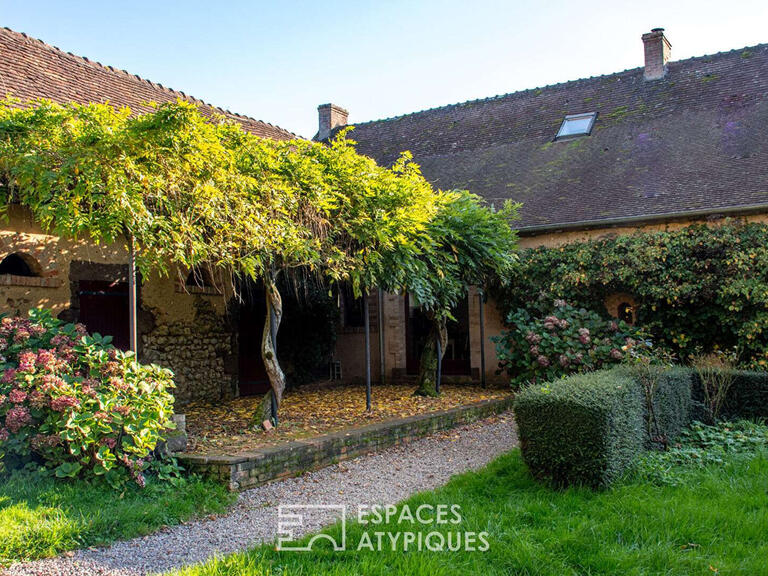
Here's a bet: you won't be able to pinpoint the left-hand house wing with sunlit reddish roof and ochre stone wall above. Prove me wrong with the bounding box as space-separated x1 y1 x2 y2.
0 28 296 402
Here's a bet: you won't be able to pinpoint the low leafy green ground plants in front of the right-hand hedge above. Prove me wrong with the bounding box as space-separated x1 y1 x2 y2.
629 420 768 486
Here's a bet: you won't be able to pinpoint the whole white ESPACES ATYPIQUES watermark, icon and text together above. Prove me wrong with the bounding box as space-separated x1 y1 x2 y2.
277 504 490 552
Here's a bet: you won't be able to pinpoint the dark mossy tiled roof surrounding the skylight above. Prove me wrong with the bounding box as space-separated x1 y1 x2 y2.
342 44 768 231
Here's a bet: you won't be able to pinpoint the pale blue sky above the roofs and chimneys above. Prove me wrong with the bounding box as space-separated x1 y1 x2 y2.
0 0 768 137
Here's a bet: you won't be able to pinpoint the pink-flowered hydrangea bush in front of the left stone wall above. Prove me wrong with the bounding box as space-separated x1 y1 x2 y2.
0 310 173 486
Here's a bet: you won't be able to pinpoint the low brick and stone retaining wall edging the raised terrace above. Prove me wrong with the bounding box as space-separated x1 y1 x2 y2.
176 396 513 490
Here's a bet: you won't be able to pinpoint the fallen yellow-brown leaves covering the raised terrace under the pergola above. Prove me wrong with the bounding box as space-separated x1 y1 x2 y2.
184 384 510 454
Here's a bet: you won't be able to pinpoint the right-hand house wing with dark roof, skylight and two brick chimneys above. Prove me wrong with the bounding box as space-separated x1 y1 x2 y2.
315 29 768 379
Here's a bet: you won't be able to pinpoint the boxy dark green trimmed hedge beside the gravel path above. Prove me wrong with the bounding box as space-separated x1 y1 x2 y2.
514 367 692 488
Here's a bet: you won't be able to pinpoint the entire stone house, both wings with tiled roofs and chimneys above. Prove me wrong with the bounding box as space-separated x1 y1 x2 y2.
0 29 768 402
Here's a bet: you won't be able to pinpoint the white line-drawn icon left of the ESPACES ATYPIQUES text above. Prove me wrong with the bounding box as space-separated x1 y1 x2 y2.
277 504 347 552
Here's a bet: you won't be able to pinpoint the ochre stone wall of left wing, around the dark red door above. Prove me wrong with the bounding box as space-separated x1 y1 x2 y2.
0 207 237 405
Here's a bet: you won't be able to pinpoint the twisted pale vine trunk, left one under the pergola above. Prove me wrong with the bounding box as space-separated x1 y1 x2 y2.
254 276 285 425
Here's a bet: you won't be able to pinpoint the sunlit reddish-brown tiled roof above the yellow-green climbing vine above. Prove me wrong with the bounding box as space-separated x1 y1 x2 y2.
0 28 297 140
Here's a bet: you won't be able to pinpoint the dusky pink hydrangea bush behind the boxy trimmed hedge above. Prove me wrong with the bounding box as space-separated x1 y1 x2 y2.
493 300 642 387
